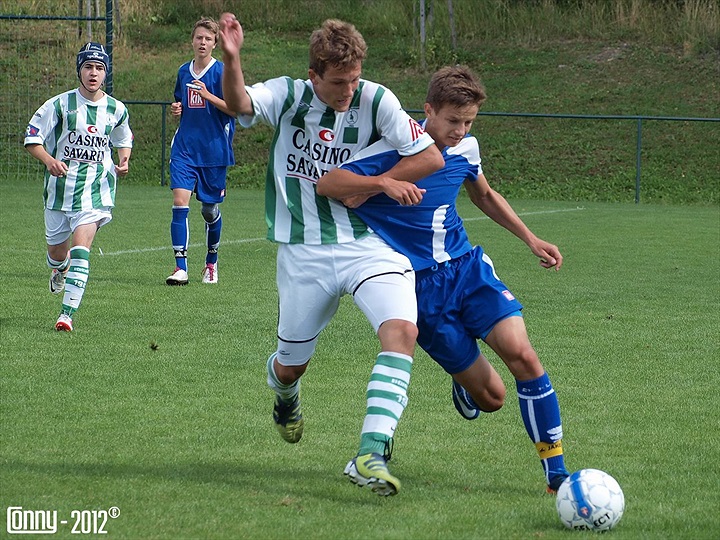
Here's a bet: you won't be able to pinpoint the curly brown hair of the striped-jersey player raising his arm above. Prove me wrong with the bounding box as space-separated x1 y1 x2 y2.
310 19 367 77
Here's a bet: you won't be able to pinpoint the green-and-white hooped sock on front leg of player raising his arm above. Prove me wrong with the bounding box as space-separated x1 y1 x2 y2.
358 352 413 455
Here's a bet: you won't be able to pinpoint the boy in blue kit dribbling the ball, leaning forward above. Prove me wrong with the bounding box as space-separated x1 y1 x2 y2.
317 66 568 493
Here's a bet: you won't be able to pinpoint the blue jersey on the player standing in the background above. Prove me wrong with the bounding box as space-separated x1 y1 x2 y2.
170 58 235 167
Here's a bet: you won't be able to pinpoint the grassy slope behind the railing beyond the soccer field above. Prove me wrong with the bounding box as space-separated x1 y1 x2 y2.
0 0 720 204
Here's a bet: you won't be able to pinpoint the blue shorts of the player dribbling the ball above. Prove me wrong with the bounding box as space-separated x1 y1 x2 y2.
415 246 522 374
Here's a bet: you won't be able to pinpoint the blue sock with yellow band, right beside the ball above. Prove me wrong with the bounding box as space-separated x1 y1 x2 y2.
515 373 568 484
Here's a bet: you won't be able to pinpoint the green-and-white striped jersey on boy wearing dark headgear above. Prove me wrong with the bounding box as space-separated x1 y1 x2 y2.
25 89 133 212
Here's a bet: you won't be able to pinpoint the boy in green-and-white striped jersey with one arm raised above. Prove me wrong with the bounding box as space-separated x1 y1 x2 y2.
220 13 444 495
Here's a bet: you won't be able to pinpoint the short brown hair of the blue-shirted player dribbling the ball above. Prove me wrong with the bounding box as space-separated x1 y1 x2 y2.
425 65 487 109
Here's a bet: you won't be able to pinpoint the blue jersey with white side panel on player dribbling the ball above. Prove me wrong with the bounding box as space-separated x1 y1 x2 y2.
343 126 482 271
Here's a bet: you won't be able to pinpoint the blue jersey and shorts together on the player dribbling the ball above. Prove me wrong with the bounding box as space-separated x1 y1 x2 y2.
342 128 522 373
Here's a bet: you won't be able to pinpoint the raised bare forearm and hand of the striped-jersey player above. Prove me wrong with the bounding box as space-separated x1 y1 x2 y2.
220 13 253 115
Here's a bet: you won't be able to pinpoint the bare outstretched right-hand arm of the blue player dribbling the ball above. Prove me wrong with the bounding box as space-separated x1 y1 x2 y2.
465 174 563 270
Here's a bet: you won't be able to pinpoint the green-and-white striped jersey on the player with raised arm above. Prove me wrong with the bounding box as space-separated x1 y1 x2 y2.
238 77 434 245
